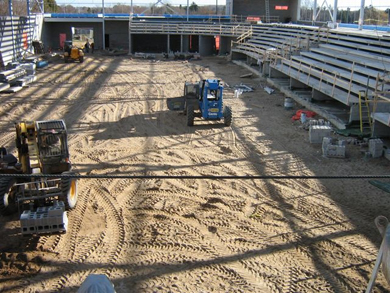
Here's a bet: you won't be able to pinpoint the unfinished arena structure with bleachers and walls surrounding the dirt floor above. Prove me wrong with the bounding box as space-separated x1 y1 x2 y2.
0 0 390 137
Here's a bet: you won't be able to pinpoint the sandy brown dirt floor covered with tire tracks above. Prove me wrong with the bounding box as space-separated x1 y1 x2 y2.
0 54 390 292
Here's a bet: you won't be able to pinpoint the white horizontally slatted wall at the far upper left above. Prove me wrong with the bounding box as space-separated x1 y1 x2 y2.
0 16 39 67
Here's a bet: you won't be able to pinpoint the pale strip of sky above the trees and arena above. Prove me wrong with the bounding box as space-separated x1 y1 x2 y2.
56 0 390 10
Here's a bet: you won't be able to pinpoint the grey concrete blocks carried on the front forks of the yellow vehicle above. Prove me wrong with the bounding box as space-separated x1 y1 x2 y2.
20 201 68 235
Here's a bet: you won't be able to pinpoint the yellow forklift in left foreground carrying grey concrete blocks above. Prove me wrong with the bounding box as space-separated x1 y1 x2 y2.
0 120 77 235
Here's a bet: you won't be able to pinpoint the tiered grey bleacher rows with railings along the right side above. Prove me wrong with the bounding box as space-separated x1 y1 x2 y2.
232 25 390 136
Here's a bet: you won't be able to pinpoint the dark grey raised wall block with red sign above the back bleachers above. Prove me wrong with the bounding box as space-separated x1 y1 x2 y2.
233 0 298 23
